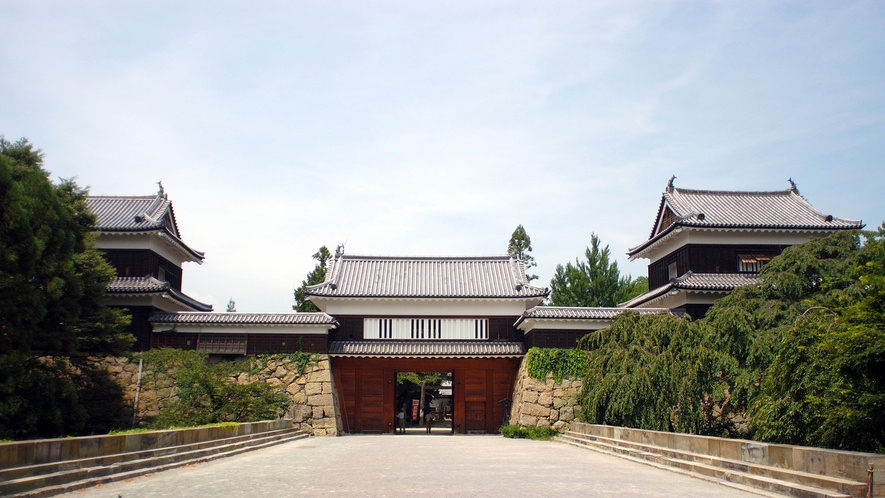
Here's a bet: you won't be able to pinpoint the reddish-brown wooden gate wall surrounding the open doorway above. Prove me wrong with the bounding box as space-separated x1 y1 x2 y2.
332 357 520 434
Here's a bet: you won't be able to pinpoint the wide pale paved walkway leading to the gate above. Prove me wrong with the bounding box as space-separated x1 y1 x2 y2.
64 434 758 498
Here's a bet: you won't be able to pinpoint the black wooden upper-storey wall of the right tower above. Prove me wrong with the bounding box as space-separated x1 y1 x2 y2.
648 244 789 289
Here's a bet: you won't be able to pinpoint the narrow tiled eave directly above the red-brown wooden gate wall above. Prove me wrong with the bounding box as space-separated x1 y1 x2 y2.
329 340 525 358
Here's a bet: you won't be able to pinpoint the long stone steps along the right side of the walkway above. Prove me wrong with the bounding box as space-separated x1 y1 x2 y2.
560 433 867 498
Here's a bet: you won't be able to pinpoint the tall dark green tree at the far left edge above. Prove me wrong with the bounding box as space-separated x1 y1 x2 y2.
0 137 134 438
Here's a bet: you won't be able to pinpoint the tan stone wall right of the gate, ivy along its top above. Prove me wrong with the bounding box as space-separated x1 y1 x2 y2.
510 357 584 431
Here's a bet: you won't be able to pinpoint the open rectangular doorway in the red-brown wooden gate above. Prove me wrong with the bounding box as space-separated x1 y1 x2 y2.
394 372 454 435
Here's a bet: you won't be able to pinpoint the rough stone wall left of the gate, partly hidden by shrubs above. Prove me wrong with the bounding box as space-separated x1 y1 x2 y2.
89 354 342 436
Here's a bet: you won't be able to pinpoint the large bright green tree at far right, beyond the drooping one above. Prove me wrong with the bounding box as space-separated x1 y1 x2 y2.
709 228 885 452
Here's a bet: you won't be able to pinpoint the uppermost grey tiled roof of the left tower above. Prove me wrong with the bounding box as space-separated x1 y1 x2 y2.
86 190 205 262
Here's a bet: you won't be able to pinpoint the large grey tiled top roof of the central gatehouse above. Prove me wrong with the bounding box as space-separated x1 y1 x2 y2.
306 254 550 298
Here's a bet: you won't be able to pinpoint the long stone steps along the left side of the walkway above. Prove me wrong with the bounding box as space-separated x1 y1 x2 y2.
0 429 308 498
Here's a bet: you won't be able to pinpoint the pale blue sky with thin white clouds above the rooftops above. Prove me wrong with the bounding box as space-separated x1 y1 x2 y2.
0 0 885 311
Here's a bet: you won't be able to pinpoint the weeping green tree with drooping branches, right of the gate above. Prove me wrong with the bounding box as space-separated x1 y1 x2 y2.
578 311 737 436
